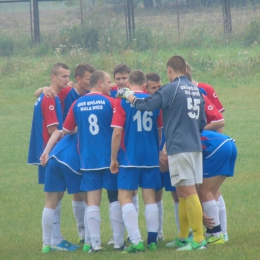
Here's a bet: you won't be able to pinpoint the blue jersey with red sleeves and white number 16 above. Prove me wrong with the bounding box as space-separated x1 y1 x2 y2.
112 92 162 168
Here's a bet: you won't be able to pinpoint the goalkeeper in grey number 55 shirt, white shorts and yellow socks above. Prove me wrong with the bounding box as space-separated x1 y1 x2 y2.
117 56 207 251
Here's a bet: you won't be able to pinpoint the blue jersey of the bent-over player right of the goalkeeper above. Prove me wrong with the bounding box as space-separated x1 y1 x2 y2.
201 130 234 160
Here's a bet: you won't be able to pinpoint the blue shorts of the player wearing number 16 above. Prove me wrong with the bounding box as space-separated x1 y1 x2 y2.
117 167 162 190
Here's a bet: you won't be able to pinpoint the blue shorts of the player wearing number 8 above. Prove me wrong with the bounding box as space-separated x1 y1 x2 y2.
80 169 117 191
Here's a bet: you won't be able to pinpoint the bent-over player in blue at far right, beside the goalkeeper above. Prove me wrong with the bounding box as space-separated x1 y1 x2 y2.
198 130 237 245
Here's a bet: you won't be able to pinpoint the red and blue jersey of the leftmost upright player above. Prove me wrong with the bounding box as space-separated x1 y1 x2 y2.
28 94 62 164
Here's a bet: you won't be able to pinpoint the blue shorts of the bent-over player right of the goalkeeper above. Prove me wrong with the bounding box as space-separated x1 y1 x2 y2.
203 141 237 178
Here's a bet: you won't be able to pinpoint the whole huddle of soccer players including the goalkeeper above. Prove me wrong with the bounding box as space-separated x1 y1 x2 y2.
28 56 236 253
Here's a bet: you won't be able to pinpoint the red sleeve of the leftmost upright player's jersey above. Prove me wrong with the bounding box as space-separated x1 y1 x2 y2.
42 96 59 127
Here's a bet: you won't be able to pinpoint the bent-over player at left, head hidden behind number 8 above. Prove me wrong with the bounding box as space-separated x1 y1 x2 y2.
40 130 84 253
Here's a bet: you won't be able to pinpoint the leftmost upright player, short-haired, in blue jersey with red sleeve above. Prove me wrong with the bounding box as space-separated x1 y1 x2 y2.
28 63 77 248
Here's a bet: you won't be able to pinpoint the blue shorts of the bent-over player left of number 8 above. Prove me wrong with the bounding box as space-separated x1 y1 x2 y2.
44 158 82 194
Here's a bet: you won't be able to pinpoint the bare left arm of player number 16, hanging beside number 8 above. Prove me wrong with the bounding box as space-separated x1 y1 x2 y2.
110 128 122 174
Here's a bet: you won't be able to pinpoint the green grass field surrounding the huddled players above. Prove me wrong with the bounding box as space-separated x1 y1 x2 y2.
0 45 260 260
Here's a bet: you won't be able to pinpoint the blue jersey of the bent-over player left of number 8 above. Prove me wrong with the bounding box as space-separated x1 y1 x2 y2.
50 134 81 174
